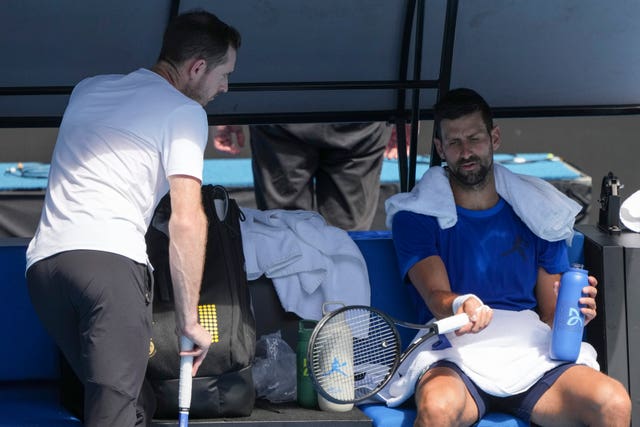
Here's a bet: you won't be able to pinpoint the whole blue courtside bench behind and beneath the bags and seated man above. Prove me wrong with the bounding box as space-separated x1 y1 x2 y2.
0 232 583 427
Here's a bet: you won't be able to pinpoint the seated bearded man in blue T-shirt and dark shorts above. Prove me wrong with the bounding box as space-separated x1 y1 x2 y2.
387 89 631 426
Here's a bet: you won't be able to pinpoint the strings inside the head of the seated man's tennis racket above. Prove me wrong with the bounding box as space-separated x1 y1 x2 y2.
311 308 400 403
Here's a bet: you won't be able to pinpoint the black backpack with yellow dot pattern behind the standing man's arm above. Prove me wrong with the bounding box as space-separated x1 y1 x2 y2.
146 185 256 418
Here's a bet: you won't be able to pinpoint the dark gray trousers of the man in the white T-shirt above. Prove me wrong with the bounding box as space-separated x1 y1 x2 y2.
27 250 155 426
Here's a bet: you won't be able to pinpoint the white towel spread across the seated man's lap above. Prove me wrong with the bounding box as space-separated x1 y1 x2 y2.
377 309 600 407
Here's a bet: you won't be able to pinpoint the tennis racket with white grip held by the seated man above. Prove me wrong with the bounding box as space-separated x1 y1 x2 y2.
307 305 469 403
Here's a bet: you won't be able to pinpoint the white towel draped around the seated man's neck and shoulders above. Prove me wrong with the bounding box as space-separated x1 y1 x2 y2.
385 163 582 244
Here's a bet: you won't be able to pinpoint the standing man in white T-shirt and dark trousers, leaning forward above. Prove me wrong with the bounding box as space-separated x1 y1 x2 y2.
27 11 240 426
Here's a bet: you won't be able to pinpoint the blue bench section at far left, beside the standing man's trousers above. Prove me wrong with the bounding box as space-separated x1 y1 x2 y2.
0 238 81 427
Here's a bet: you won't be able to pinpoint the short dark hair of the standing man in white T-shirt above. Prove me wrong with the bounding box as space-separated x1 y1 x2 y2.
158 10 240 67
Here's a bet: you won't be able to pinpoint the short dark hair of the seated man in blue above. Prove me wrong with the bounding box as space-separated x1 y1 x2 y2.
433 88 493 139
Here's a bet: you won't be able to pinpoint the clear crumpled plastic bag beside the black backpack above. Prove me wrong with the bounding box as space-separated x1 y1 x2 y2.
252 331 296 403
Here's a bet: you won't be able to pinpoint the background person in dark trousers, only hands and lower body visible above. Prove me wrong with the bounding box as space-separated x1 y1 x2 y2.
214 122 409 230
